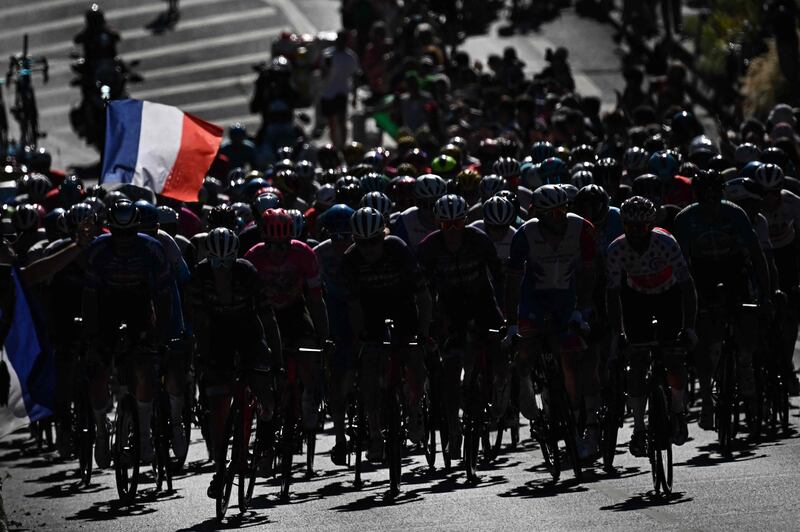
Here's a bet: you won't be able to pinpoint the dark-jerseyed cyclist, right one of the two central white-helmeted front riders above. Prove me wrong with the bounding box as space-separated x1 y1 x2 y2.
417 194 507 458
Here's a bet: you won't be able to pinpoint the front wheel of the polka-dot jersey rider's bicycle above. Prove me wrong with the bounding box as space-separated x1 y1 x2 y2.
647 386 672 495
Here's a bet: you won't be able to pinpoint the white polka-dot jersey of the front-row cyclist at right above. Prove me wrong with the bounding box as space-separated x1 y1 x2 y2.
606 227 689 294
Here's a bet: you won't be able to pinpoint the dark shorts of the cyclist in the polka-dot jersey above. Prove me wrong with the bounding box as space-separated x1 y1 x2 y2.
620 285 683 345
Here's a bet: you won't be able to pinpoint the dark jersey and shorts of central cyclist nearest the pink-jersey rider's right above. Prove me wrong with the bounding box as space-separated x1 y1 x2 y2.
342 236 425 340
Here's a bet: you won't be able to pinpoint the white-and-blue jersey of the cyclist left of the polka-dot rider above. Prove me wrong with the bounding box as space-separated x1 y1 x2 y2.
509 213 596 293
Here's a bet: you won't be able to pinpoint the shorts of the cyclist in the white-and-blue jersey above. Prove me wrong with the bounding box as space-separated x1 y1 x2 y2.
518 290 583 351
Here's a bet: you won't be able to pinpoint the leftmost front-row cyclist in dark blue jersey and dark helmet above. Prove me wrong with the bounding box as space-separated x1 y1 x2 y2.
82 199 174 468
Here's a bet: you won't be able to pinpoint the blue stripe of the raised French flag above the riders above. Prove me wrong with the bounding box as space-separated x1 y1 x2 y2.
100 100 144 183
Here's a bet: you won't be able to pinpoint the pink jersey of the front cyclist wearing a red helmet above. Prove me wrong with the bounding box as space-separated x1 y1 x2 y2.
244 240 322 309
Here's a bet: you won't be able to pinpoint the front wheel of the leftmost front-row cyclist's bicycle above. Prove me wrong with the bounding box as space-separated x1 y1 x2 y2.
113 394 140 504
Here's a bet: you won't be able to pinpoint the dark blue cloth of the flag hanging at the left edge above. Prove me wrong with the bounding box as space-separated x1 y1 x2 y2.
5 270 55 423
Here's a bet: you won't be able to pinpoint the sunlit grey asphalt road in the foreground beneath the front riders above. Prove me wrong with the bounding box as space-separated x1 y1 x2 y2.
0 392 800 531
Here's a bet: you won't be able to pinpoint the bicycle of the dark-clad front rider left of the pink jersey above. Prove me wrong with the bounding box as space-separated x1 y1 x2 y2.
216 368 272 521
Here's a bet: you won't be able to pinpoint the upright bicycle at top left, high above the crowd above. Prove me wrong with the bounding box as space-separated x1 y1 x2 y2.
6 33 50 146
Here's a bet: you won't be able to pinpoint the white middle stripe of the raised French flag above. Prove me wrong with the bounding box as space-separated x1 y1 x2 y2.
133 102 183 192
